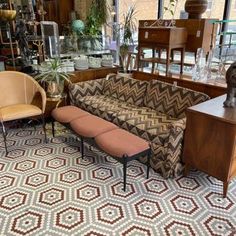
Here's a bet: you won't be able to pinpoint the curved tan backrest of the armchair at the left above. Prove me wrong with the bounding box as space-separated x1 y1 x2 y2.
0 71 46 112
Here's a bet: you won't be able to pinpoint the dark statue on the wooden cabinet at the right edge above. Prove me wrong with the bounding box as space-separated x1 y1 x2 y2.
224 61 236 107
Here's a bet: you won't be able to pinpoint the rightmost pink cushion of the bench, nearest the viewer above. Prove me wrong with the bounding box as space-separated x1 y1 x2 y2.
95 129 149 158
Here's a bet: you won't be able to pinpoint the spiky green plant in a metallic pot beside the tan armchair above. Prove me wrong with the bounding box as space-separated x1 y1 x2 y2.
35 58 73 98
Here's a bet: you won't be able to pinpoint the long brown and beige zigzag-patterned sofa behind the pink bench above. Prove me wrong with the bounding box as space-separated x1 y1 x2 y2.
69 74 209 178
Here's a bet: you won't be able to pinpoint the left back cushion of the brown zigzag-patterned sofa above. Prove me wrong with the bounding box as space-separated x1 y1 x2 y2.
103 74 148 106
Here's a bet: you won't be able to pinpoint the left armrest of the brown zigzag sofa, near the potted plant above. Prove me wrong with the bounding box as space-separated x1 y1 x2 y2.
68 78 106 105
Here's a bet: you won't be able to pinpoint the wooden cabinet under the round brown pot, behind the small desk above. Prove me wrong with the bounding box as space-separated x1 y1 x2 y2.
139 19 217 53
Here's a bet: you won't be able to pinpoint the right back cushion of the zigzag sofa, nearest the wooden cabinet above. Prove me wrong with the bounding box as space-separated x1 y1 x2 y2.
144 80 209 118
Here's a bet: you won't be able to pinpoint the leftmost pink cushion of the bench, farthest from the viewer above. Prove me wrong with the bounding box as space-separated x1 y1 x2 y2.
51 106 90 123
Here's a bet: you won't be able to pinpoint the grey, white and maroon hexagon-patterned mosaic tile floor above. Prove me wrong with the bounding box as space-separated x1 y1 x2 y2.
0 126 236 236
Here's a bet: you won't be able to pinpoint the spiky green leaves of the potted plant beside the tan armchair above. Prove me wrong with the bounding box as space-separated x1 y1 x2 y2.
35 58 72 84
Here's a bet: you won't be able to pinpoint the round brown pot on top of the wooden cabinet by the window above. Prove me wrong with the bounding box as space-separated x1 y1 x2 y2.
184 0 207 19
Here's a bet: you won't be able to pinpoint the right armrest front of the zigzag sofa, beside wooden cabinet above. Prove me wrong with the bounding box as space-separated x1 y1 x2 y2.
164 118 186 177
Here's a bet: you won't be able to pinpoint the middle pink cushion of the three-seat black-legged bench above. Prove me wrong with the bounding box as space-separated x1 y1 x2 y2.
70 115 118 138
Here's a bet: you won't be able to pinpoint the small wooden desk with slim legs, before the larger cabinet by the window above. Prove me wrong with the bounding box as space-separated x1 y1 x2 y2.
138 27 187 75
